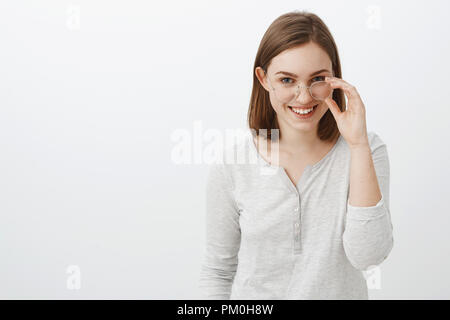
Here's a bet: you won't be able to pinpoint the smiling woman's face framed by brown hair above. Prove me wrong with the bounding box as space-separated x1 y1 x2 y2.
255 42 333 132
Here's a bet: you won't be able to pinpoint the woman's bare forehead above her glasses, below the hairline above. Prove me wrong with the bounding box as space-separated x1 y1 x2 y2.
269 42 332 77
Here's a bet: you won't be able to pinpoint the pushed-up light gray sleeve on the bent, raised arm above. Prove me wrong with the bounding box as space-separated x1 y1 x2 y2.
343 134 394 270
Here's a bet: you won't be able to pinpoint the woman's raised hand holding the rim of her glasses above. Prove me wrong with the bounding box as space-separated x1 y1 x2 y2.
325 77 369 148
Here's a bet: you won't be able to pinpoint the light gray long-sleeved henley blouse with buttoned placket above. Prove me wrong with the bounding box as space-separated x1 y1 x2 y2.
199 129 393 300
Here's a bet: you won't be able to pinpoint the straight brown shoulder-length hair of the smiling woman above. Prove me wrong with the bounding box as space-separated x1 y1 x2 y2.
248 10 345 141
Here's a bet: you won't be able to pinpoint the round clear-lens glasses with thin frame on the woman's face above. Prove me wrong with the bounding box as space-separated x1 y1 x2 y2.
267 73 333 104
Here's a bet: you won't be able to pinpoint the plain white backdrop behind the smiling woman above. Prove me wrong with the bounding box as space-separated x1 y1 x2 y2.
0 0 450 299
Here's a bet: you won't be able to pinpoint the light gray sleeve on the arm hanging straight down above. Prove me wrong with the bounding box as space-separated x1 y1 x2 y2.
199 163 241 300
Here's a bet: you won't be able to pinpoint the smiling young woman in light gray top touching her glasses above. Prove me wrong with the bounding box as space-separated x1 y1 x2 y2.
200 11 393 299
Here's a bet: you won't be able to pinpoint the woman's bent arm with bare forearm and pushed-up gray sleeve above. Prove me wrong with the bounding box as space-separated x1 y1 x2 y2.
343 135 394 270
